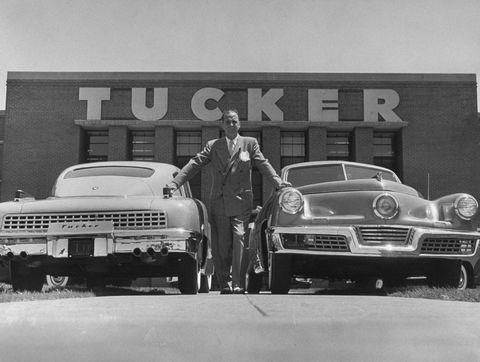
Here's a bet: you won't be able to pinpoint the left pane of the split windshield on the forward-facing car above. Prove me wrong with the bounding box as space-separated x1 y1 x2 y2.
287 165 345 187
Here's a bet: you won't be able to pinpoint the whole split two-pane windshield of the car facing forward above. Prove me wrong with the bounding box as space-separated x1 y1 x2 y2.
287 164 398 187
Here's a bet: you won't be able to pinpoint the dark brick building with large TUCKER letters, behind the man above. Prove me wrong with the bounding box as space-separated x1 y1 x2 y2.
0 72 480 203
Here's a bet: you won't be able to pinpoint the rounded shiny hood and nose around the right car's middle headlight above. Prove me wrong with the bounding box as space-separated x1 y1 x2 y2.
271 179 471 229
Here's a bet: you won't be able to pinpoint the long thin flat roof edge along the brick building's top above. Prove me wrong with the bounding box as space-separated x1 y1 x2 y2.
7 71 476 82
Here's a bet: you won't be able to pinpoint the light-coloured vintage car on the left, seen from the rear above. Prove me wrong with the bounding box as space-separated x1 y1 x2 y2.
0 161 212 294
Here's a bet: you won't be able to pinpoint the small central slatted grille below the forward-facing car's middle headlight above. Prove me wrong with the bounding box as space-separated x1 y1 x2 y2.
357 225 413 245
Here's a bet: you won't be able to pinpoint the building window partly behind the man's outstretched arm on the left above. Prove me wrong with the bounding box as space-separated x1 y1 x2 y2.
175 131 202 199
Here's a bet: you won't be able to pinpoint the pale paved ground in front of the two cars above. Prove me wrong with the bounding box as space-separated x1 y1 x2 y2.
0 292 480 362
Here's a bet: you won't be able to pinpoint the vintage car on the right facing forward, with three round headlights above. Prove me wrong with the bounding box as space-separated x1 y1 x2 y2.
247 161 480 294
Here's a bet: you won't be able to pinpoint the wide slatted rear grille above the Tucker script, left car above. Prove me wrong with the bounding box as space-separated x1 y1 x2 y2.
2 211 167 232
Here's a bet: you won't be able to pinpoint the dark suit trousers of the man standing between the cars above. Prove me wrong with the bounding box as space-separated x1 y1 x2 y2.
210 198 251 289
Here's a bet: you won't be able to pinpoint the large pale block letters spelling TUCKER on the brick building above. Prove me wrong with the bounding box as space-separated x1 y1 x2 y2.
79 87 402 122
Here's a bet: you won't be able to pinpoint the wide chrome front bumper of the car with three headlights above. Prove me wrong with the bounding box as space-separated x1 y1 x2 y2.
267 225 480 258
